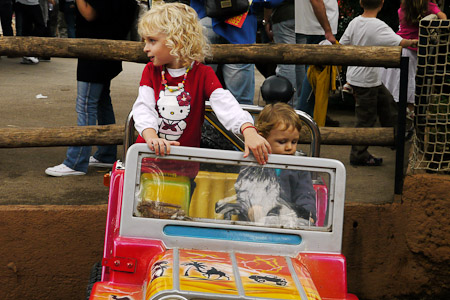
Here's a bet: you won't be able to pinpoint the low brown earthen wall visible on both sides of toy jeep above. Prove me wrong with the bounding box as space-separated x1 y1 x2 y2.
0 175 450 300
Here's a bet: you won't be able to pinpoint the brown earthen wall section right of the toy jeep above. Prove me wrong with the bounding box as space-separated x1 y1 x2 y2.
343 174 450 300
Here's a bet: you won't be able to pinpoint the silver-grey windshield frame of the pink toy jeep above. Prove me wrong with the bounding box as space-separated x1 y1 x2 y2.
119 144 345 255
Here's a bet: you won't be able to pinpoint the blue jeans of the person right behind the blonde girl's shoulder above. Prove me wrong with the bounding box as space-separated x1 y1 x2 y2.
200 17 255 104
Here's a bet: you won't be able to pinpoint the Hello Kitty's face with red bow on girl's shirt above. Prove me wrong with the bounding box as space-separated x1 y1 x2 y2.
157 89 191 121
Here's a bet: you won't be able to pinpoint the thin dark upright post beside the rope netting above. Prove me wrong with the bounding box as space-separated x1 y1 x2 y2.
394 56 409 195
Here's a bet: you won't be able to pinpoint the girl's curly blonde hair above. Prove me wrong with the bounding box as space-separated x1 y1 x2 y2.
138 2 211 67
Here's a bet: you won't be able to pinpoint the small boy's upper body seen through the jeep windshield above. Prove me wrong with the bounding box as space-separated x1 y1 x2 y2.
235 167 316 228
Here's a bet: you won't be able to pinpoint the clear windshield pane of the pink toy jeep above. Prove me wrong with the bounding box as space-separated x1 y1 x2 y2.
134 158 329 229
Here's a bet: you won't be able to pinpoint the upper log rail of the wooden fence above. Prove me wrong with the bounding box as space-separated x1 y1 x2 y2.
0 36 401 68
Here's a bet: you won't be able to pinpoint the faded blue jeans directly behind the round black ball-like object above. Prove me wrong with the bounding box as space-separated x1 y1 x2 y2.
272 19 298 107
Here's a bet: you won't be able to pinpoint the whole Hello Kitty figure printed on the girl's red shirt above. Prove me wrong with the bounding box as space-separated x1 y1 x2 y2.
157 89 191 141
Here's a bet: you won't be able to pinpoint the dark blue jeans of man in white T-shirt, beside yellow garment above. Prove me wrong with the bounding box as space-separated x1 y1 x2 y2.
296 33 325 117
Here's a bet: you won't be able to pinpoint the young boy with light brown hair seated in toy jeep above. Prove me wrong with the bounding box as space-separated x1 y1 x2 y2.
235 103 316 228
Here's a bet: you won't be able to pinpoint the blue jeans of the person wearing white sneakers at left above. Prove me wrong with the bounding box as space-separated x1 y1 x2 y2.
63 81 117 172
